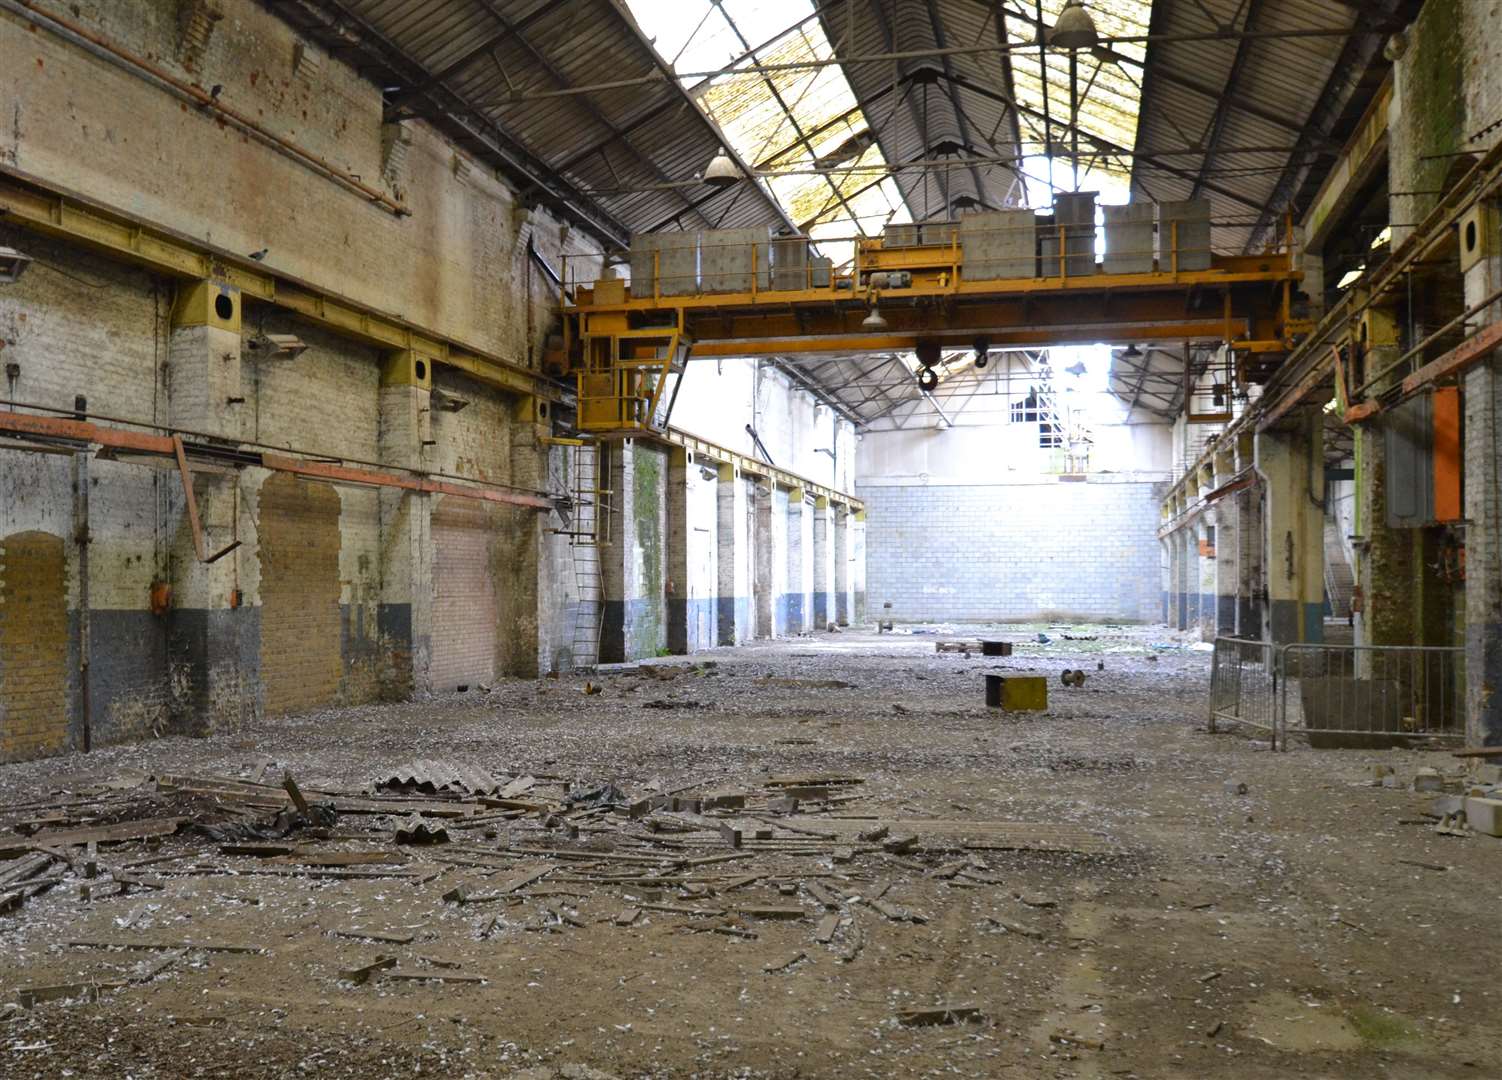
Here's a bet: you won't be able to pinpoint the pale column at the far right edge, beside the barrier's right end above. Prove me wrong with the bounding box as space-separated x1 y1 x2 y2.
1461 247 1502 747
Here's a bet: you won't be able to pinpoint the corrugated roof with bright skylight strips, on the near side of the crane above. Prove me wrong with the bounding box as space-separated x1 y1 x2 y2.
263 0 1400 261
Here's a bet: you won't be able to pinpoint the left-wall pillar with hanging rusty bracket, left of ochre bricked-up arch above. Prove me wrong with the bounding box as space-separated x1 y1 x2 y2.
167 281 258 733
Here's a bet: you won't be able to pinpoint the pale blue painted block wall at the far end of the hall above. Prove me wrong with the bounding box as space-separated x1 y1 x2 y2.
858 482 1163 622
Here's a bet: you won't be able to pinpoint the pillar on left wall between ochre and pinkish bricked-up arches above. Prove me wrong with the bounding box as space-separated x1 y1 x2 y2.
376 353 433 695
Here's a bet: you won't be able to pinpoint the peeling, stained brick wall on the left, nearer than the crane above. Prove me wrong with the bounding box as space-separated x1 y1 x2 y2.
0 0 586 759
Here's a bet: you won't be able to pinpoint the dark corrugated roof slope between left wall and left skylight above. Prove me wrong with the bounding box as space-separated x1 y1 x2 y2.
263 0 784 239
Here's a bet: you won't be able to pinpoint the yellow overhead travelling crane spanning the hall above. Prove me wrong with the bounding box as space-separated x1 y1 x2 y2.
553 219 1311 437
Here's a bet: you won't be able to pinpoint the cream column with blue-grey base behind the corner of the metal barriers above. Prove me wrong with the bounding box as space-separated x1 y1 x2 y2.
1256 407 1325 644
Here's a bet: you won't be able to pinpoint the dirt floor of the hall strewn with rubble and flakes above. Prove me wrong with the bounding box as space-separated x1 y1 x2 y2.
0 628 1502 1080
